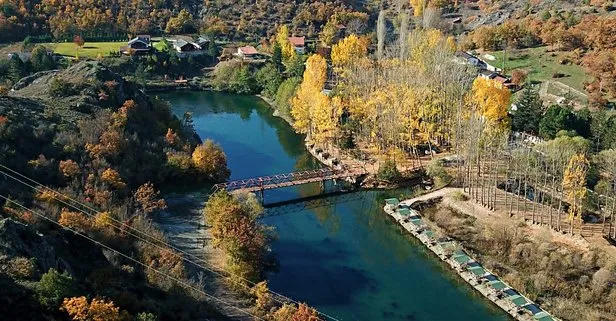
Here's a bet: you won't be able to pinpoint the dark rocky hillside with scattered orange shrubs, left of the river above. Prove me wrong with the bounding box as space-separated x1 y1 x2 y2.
0 62 228 321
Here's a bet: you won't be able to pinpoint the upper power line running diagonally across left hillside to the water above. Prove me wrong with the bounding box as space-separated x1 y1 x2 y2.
0 164 339 321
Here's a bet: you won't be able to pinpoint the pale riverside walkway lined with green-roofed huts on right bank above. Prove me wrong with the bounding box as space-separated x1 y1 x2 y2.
384 188 557 321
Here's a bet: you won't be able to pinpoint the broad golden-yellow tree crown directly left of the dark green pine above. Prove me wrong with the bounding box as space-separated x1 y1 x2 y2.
470 77 511 129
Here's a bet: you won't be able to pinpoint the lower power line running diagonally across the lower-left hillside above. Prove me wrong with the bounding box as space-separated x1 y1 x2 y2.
0 195 266 321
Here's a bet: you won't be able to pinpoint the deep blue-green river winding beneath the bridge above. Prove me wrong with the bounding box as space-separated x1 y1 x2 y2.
158 92 510 321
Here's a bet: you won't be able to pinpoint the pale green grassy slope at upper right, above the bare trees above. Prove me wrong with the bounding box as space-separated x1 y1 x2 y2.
482 47 588 92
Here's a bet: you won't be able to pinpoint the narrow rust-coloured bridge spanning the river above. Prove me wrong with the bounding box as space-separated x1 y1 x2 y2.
213 167 367 192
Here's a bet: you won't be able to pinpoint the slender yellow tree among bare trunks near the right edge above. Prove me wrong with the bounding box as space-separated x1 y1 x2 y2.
563 154 590 234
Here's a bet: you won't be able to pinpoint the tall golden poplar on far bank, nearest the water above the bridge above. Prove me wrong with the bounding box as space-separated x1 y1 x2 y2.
291 55 329 136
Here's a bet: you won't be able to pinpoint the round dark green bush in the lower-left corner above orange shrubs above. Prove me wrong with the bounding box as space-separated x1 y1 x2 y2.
36 269 76 310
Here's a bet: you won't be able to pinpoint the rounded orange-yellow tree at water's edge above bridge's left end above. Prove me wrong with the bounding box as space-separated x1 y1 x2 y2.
192 139 231 182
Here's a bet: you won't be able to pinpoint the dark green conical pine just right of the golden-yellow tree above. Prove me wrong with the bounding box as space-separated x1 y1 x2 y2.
511 86 543 135
